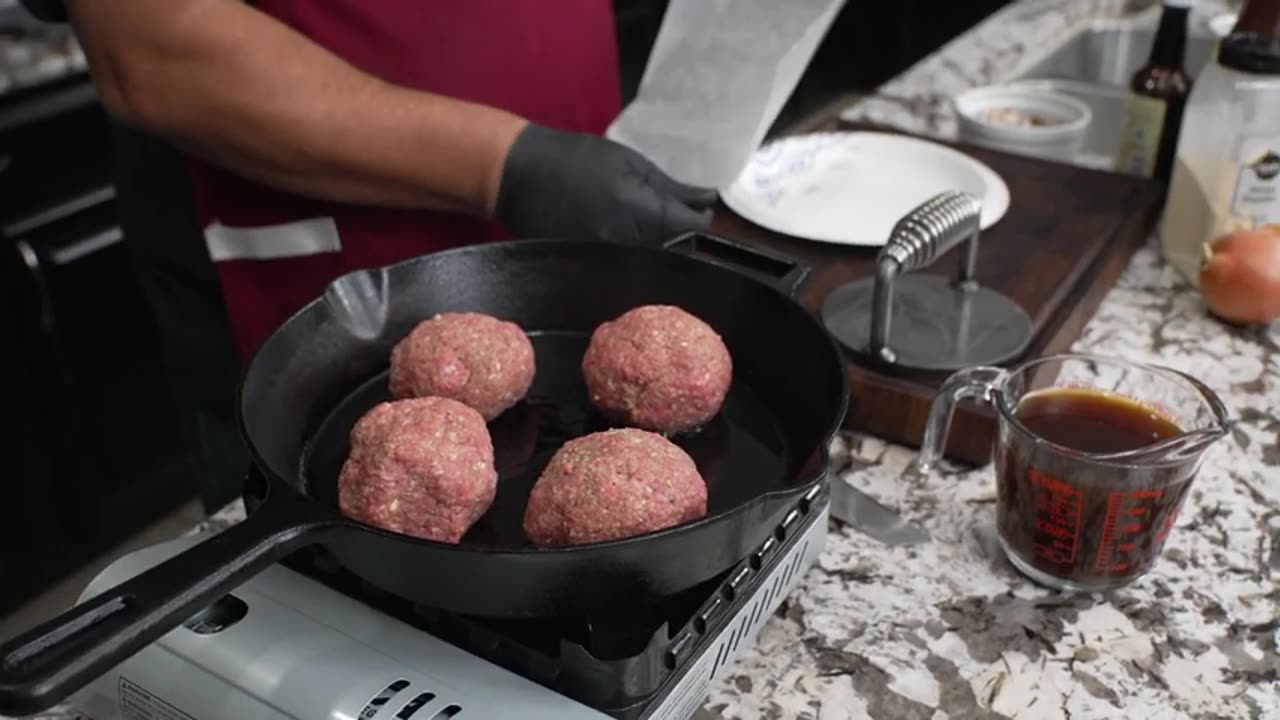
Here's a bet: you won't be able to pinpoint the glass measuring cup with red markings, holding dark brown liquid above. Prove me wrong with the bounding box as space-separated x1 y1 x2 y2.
915 355 1229 591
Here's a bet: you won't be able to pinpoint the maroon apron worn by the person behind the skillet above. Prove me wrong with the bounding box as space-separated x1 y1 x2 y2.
193 0 621 360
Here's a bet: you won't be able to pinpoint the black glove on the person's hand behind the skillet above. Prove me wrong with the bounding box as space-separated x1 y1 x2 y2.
494 123 716 245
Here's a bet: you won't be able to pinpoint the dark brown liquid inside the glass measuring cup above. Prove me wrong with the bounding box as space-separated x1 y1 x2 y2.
996 388 1196 585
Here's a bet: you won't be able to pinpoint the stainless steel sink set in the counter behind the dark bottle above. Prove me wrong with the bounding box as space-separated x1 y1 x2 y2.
1010 13 1216 169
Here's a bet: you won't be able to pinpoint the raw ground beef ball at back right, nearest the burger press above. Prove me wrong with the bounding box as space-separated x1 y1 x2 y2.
582 305 733 433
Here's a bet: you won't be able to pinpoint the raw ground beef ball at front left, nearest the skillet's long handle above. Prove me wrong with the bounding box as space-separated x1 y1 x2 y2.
338 397 498 542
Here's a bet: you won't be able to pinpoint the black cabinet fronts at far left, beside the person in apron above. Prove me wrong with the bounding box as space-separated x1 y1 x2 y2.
0 85 195 612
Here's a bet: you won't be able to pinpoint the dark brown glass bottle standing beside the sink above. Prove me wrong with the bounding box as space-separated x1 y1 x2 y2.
1117 0 1192 182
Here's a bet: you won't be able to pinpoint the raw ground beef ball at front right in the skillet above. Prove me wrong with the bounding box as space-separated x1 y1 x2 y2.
525 428 707 547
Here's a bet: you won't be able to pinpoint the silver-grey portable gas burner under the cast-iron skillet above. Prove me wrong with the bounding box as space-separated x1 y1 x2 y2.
73 484 828 720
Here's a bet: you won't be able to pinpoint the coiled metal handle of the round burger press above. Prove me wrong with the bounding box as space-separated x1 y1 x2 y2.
869 190 982 363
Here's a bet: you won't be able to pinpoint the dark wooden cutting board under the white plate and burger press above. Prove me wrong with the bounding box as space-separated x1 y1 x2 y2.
713 124 1162 464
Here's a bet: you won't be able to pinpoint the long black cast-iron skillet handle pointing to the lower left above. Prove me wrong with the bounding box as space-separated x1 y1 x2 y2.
0 483 340 716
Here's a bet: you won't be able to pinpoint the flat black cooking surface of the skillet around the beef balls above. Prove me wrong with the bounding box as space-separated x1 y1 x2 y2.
301 328 788 547
